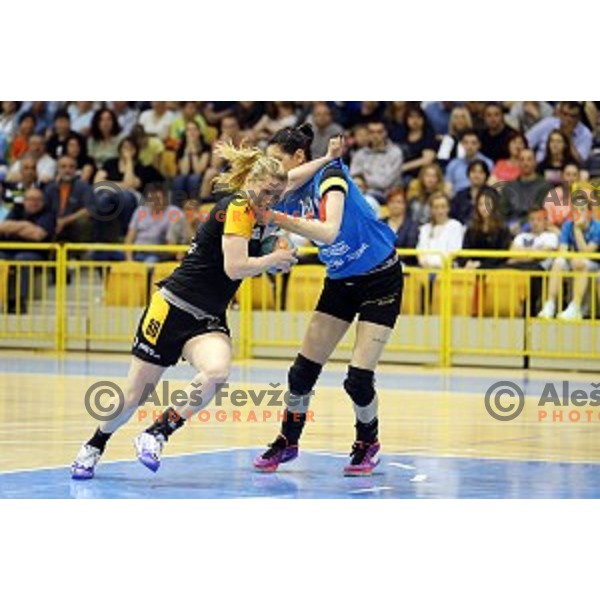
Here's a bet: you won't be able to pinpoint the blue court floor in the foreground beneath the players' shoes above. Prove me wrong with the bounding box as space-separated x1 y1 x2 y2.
0 448 600 499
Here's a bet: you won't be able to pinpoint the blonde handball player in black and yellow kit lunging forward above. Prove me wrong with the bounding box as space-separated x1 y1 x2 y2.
71 139 341 479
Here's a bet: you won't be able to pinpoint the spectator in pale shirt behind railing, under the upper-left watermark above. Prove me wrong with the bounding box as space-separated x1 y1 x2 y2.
124 183 183 263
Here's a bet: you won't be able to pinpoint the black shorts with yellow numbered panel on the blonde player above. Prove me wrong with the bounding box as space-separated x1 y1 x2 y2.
131 292 231 367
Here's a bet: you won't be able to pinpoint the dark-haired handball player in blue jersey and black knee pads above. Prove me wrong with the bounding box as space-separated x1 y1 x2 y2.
254 125 403 476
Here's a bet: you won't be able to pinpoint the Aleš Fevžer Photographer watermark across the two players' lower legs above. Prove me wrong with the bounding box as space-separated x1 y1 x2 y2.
84 380 314 423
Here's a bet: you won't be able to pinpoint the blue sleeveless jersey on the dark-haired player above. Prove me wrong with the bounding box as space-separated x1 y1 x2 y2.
274 159 395 279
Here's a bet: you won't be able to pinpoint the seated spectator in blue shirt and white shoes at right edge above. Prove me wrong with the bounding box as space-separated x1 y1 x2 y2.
538 200 600 321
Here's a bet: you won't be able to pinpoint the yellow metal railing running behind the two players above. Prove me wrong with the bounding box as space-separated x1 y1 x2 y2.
0 243 600 366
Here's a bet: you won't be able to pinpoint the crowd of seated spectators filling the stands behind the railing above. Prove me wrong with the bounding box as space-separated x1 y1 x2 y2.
0 101 600 318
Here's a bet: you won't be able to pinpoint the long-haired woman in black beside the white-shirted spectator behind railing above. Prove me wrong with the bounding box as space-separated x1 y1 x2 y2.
457 190 512 269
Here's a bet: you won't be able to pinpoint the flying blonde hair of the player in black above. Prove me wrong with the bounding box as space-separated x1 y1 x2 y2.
215 142 287 191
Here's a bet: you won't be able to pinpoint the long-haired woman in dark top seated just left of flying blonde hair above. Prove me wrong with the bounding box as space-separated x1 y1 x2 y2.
173 121 210 204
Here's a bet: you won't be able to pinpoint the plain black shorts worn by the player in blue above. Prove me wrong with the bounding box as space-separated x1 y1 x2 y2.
316 261 404 328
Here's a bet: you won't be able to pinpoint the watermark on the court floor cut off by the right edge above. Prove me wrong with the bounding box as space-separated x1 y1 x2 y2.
484 381 600 423
